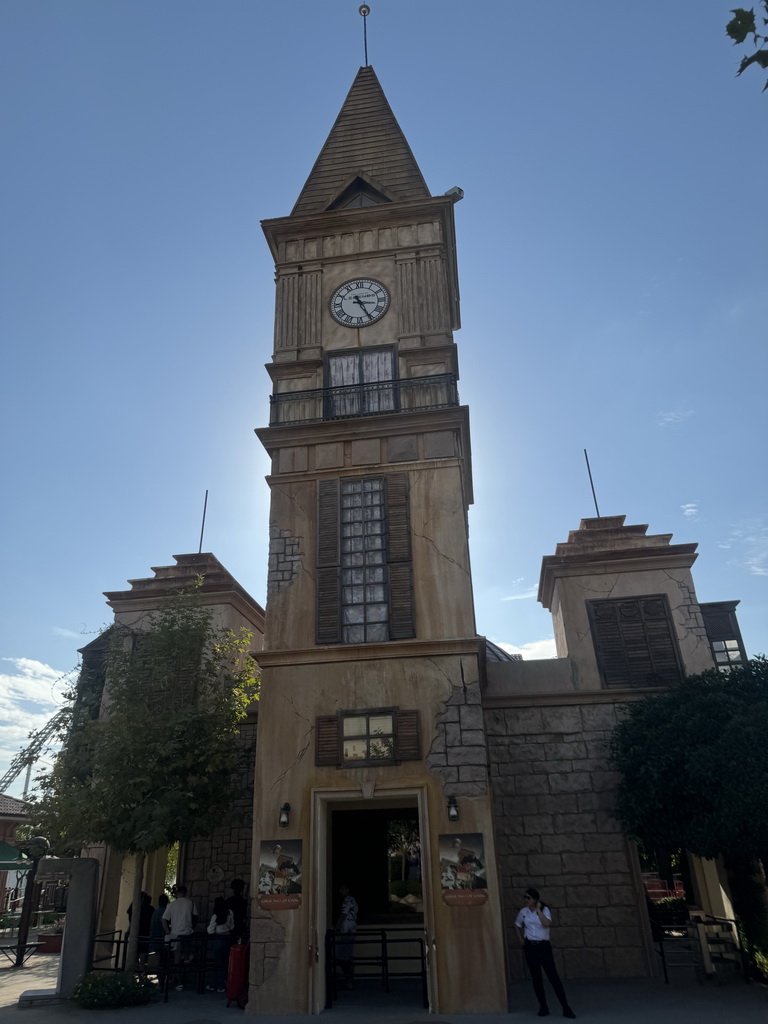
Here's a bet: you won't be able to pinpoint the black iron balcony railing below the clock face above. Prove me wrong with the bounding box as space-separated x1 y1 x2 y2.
269 374 459 427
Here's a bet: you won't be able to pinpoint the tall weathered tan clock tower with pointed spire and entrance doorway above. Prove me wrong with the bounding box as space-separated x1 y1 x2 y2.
248 67 507 1014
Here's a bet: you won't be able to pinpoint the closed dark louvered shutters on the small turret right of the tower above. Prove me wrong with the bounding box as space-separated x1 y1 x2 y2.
587 594 683 686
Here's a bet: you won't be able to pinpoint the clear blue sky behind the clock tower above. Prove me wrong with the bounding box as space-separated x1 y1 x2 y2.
0 0 768 792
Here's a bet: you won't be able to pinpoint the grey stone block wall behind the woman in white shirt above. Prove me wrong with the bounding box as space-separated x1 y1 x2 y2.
484 698 652 978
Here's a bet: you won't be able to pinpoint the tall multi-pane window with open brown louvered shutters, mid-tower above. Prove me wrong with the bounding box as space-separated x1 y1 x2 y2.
317 473 415 644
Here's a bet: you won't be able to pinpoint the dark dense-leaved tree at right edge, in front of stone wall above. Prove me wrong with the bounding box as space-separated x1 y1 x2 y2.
611 656 768 953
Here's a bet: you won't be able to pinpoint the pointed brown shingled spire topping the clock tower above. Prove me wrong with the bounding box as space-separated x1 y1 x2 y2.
291 67 429 216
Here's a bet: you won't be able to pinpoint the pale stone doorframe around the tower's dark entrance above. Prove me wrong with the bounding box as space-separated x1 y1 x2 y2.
309 781 438 1014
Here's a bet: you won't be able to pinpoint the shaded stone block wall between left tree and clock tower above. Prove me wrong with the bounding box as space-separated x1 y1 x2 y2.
178 713 256 924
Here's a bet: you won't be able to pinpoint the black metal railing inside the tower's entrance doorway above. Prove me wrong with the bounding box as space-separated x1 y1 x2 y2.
326 928 429 1010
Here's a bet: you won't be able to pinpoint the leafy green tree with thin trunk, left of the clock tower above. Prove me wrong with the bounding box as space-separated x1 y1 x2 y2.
33 589 257 970
